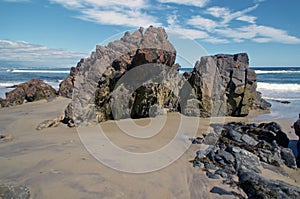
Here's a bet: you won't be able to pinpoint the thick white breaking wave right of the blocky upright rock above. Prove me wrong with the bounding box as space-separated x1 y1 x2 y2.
257 82 300 92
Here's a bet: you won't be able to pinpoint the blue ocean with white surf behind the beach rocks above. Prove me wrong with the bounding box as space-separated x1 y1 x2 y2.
0 67 300 120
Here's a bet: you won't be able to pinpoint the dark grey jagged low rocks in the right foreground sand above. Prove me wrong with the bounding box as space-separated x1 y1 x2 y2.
192 122 300 198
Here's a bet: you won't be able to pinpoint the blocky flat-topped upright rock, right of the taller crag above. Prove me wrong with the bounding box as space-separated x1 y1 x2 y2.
189 53 256 117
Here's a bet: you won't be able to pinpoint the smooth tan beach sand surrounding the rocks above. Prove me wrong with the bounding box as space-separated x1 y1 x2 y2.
0 98 300 199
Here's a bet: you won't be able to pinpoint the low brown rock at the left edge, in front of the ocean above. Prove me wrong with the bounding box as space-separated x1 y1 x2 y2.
0 79 57 107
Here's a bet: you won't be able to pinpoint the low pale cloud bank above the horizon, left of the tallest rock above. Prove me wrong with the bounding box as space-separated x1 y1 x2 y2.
0 40 87 67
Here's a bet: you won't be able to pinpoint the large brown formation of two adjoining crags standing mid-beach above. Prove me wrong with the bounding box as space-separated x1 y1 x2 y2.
59 26 268 124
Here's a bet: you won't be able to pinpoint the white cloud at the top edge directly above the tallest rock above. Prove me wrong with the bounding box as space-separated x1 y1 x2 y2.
50 0 162 27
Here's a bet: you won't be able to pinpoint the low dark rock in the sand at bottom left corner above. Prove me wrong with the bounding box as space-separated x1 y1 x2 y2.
0 184 30 199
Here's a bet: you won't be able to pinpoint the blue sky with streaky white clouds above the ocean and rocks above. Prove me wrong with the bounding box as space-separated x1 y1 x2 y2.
0 0 300 67
